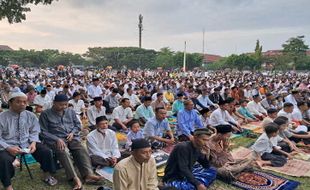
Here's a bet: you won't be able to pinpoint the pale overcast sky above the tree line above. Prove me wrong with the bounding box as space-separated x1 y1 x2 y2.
0 0 310 55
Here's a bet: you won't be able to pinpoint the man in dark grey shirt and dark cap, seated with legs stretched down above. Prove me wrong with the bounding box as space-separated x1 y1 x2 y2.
40 94 102 190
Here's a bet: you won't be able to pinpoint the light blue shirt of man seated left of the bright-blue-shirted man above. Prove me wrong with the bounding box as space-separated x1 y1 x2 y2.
143 117 171 137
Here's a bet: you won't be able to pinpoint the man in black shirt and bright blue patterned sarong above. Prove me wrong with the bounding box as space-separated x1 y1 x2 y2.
163 129 216 190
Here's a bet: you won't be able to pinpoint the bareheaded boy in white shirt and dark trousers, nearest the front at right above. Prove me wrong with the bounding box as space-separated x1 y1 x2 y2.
252 123 291 167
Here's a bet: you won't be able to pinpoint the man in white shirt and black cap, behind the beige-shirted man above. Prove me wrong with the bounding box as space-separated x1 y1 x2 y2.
87 116 121 167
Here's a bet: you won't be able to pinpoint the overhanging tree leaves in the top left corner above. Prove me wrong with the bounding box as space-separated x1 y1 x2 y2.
0 0 54 24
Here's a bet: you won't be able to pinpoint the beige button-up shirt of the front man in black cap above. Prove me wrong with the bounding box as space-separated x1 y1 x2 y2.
113 156 158 190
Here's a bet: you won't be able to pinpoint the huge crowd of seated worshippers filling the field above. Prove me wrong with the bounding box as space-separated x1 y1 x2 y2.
0 66 310 190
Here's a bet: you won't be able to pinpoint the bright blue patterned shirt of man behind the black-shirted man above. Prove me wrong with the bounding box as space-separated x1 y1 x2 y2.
177 109 203 136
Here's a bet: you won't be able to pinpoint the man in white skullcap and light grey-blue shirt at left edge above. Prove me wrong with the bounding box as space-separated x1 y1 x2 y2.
0 92 57 190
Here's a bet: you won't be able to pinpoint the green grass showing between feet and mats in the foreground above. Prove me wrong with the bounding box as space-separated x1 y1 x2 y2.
5 138 310 190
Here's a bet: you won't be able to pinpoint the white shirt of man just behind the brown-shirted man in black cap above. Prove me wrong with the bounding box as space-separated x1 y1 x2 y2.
210 108 237 126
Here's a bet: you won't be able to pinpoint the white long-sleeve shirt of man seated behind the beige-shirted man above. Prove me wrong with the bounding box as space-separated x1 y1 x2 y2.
87 129 121 158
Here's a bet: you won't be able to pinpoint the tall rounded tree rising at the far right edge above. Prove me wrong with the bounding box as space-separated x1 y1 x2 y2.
282 36 309 70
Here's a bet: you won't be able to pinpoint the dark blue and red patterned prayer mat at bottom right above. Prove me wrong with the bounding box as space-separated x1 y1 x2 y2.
232 171 299 190
